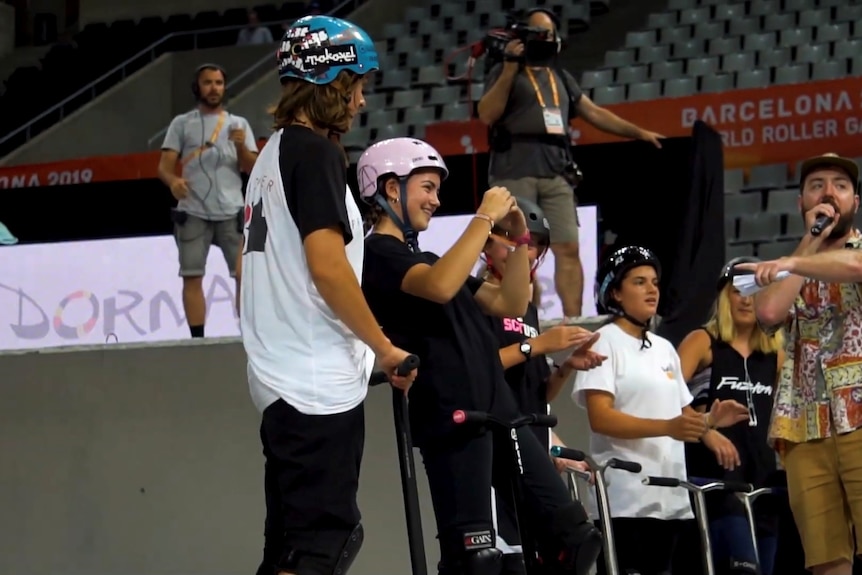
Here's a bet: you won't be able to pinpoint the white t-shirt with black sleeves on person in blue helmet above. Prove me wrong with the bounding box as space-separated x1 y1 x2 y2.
240 126 374 415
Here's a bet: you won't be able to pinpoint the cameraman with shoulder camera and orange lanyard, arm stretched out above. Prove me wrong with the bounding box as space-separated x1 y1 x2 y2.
478 8 663 318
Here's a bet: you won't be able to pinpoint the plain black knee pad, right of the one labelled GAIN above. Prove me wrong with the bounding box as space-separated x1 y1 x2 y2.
540 503 602 575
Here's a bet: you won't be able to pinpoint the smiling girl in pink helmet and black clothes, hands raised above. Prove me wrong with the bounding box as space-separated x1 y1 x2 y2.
357 138 601 575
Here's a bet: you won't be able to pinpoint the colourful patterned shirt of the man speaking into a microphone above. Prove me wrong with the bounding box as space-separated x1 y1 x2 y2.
769 230 862 449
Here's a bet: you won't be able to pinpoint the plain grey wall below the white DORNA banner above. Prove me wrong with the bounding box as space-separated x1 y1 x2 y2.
0 340 586 575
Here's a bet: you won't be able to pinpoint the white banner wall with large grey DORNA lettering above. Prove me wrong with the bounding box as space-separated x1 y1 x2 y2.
0 206 598 350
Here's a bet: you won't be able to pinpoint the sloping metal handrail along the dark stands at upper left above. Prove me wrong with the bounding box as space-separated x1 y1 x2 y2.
0 0 364 151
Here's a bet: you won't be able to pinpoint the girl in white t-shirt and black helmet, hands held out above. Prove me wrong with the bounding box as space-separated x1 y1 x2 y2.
572 247 748 575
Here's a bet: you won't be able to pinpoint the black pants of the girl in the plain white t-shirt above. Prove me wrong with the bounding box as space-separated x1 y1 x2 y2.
596 517 684 575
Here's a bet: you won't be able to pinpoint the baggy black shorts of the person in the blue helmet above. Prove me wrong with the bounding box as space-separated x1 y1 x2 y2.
258 400 365 575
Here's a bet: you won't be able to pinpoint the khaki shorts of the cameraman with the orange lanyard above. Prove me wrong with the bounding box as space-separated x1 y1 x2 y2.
491 176 578 244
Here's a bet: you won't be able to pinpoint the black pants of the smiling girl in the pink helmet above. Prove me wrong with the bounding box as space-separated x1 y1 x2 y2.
421 429 586 565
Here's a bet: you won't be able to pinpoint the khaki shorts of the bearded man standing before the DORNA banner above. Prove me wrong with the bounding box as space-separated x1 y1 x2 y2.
174 214 242 277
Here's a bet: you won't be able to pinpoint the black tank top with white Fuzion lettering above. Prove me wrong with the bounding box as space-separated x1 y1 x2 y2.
686 328 778 487
